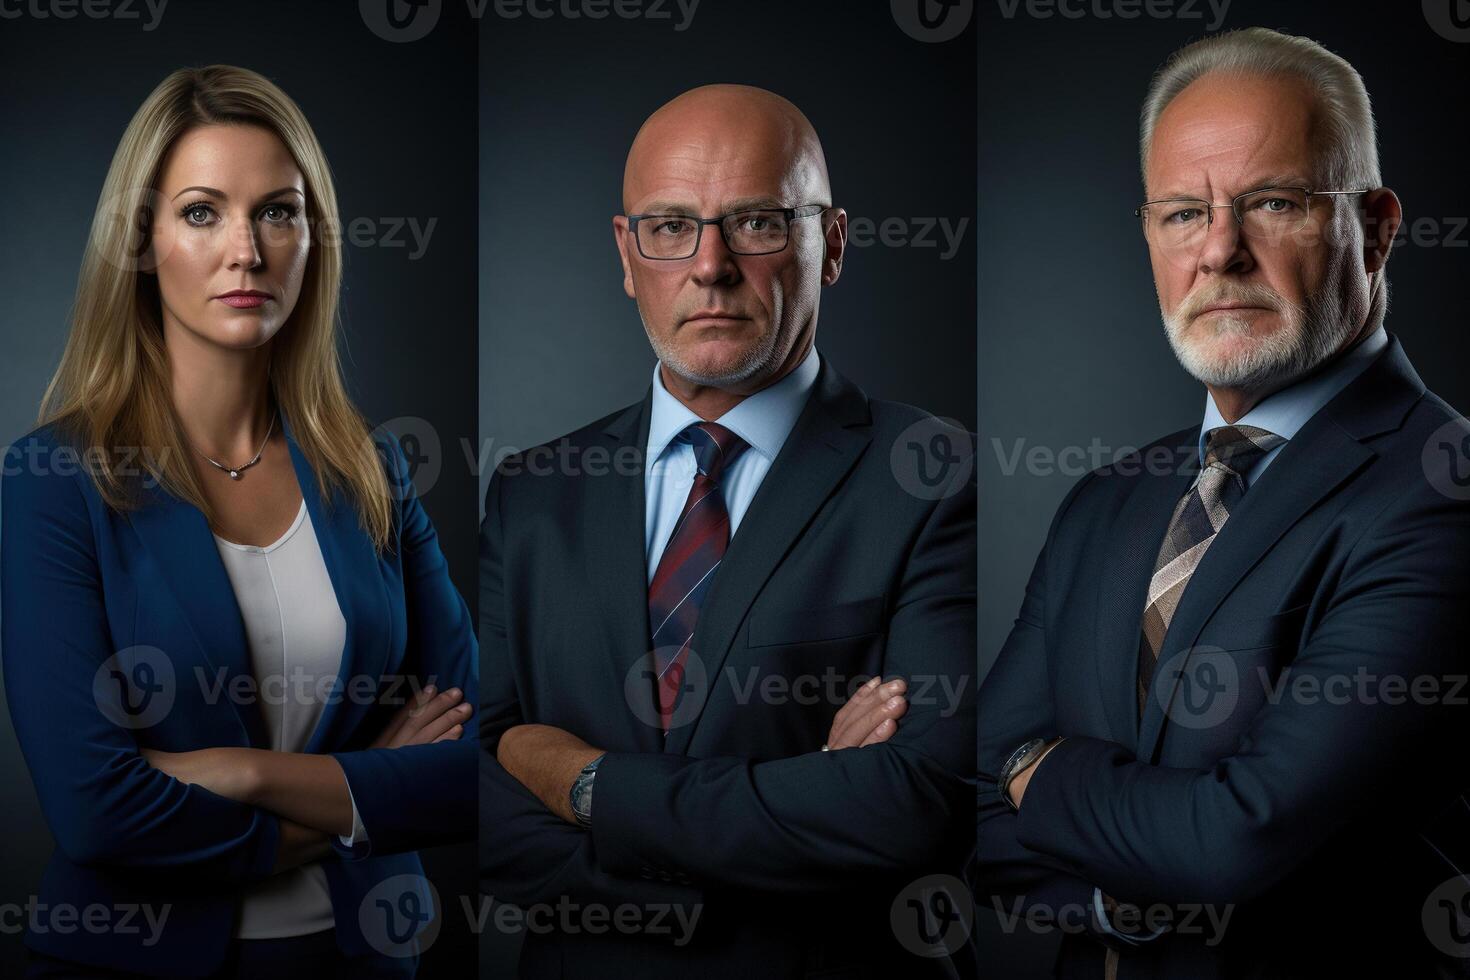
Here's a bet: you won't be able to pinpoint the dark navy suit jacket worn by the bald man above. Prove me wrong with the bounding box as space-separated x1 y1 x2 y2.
481 360 976 980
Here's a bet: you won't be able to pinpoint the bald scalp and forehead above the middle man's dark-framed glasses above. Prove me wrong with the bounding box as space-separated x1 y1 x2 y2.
623 85 832 213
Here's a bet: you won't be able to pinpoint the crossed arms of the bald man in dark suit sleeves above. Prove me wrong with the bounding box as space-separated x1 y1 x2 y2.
481 473 975 905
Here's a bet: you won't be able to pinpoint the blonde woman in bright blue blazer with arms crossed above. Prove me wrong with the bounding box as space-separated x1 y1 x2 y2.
0 65 478 980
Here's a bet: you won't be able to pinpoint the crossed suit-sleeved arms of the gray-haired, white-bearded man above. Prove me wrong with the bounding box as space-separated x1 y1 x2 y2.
978 470 1470 940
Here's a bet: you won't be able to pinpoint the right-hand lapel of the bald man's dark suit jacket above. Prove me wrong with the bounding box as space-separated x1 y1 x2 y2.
667 360 872 754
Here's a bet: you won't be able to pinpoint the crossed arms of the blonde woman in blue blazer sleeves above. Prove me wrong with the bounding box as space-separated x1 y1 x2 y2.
0 435 478 883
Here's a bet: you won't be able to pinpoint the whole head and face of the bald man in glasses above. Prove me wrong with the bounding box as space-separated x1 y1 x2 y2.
613 85 847 419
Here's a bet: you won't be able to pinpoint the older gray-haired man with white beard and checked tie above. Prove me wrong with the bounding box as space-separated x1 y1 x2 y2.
978 28 1470 980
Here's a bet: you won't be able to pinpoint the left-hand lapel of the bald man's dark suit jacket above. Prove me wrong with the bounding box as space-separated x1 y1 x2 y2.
584 385 664 752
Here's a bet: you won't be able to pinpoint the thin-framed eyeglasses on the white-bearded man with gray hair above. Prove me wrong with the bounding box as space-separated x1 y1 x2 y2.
1133 187 1367 251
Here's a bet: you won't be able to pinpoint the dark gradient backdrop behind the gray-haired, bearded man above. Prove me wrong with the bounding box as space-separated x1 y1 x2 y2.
978 0 1470 977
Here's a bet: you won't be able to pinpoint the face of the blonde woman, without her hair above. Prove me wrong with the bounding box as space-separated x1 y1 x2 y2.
151 125 310 350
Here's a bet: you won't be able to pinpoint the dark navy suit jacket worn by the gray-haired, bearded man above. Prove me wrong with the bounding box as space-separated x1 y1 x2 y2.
976 338 1470 980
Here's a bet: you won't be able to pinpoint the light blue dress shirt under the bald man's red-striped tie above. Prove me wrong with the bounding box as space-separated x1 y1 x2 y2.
644 345 822 580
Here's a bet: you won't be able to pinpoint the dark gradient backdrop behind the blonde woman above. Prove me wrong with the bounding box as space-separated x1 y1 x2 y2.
0 0 478 977
